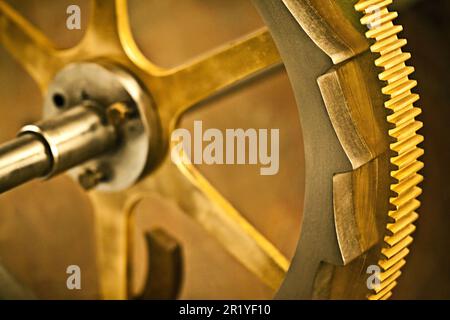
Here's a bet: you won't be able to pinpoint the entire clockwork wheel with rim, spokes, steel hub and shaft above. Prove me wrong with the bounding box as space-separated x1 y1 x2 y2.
0 0 424 300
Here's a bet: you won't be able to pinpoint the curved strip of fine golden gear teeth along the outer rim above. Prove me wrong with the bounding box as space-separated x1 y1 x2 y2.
355 0 423 300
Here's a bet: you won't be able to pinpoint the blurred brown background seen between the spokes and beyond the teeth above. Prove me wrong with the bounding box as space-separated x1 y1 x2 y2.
0 0 450 299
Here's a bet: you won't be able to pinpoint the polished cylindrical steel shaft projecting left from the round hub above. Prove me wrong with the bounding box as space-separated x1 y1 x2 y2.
0 105 117 193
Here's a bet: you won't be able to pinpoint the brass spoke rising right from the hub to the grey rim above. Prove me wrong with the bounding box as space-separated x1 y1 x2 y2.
152 28 281 124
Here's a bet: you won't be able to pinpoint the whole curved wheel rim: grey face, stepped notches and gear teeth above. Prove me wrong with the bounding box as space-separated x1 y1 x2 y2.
257 0 422 299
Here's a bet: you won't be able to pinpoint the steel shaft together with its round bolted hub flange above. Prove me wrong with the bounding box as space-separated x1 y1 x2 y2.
0 63 161 191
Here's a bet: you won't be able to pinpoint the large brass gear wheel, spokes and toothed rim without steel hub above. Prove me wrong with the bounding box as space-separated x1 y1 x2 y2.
0 0 423 299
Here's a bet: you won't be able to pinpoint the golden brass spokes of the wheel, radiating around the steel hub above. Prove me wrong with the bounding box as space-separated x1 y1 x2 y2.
0 0 288 299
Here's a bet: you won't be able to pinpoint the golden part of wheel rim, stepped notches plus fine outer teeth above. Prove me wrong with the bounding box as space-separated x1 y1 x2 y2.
274 0 423 299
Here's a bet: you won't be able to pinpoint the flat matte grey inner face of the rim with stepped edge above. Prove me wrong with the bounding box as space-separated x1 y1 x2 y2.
255 1 351 299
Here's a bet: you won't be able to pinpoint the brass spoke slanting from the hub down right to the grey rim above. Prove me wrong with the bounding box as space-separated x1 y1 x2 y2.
134 159 289 290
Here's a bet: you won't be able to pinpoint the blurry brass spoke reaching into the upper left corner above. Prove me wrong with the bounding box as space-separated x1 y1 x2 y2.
0 1 62 91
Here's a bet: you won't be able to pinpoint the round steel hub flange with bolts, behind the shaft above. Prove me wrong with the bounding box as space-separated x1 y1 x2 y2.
44 62 162 192
